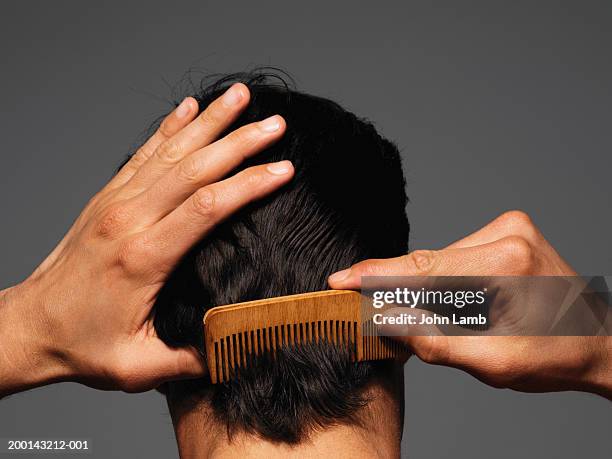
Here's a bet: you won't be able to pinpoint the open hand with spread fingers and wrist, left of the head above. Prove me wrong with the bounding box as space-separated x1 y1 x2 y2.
0 84 294 397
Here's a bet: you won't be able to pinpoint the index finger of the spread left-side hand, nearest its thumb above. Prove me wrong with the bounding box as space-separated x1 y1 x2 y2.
145 161 294 274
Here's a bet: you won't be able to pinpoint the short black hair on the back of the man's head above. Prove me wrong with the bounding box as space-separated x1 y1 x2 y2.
146 72 409 444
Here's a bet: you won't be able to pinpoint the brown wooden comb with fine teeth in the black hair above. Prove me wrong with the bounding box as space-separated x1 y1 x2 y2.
204 290 407 384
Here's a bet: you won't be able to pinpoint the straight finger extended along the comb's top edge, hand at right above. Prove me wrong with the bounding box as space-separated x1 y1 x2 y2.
329 236 534 289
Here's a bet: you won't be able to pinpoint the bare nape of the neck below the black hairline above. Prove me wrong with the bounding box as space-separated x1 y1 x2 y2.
170 388 402 459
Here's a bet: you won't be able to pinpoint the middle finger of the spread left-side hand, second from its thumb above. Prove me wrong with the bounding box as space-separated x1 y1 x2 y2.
133 115 285 224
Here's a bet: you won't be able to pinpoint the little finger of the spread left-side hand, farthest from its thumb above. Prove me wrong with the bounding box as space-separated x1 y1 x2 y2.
109 97 198 188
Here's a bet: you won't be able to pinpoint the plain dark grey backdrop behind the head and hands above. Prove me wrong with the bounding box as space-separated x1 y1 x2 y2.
0 0 612 458
